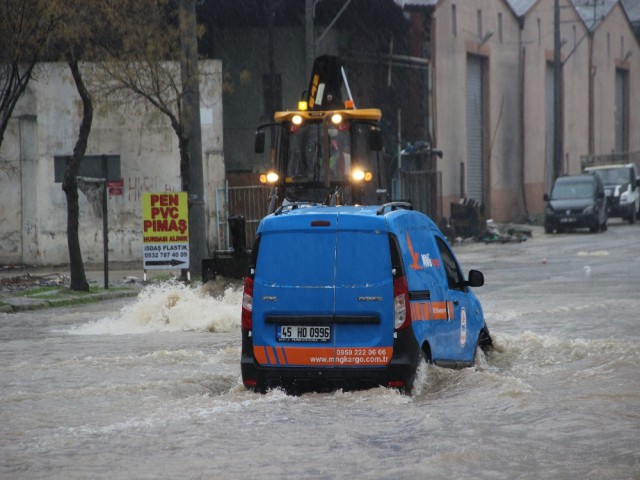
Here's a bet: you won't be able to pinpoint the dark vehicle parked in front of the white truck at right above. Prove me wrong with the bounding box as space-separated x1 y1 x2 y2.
544 174 608 233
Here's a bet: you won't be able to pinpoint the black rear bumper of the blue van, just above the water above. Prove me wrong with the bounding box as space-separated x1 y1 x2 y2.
240 328 422 393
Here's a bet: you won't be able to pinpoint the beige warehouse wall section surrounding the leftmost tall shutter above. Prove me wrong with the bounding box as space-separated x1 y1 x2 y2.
433 0 522 220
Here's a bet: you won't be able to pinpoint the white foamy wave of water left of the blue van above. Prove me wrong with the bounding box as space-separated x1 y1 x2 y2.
69 280 242 335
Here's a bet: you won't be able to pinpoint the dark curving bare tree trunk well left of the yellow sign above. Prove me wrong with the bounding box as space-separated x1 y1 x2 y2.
62 58 93 291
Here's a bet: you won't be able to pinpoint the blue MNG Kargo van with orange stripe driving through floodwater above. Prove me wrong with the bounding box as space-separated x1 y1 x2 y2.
241 202 492 392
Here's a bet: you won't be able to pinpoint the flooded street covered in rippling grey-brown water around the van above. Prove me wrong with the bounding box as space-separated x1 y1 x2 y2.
0 220 640 479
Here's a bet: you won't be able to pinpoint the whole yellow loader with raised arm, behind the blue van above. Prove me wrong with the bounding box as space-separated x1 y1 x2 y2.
255 56 382 213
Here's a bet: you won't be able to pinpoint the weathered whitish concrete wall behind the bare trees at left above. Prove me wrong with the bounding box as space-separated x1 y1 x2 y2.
0 61 224 265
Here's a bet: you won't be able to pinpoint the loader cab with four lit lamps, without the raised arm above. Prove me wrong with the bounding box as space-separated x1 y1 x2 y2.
256 114 382 208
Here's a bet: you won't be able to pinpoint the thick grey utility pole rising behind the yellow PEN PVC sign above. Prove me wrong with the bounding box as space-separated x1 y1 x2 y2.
180 0 208 273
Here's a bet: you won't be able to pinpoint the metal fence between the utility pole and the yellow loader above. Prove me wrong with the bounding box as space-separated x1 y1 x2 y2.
216 185 269 250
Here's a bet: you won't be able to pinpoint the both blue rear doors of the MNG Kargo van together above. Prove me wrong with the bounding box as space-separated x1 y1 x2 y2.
252 213 393 367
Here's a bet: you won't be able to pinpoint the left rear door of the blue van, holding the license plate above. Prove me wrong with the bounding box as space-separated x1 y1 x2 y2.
253 214 337 366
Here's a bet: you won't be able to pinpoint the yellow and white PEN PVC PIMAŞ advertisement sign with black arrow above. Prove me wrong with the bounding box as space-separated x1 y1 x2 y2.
142 192 189 270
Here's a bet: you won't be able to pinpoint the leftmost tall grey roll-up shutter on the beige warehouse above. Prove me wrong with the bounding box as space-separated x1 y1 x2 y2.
467 56 484 203
